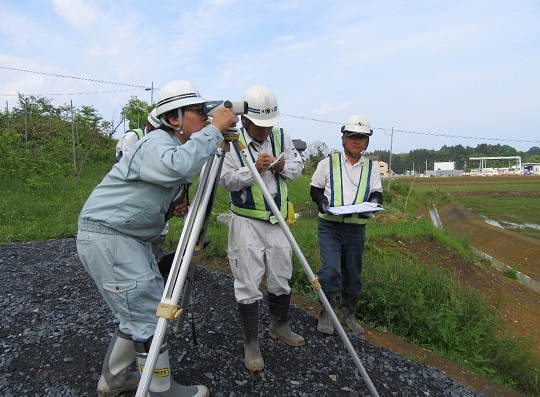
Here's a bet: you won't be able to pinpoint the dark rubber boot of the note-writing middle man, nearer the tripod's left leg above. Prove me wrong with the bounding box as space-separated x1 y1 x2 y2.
238 301 264 371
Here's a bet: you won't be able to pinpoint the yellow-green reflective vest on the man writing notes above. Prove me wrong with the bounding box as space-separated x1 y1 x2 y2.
230 128 287 224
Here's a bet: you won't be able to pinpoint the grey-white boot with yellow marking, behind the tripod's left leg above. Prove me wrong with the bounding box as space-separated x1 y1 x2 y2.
135 341 209 397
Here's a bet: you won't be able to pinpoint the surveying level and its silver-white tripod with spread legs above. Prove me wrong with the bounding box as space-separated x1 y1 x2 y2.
136 101 379 397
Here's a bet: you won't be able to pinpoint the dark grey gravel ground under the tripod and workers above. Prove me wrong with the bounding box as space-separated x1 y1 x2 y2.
0 239 479 397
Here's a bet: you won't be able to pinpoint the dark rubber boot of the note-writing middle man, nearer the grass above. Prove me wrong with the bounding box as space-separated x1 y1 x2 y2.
268 293 305 346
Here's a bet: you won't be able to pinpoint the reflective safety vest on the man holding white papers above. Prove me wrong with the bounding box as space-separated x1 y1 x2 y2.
319 152 373 225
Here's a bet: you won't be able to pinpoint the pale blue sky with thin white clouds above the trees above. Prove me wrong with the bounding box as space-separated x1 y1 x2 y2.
0 0 540 153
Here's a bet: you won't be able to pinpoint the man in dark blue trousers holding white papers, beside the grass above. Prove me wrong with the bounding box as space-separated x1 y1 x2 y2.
310 115 383 335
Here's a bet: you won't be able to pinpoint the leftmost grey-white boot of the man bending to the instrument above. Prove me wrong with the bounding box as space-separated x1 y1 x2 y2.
97 330 140 397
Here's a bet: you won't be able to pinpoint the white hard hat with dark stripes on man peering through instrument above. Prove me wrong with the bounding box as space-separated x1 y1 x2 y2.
156 80 205 118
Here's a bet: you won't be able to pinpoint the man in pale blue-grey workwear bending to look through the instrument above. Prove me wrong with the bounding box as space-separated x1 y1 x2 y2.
77 80 237 397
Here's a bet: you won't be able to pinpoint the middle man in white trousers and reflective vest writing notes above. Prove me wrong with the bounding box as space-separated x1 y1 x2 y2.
219 85 304 371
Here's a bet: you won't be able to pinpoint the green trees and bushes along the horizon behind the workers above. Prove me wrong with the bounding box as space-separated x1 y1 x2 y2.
0 95 540 186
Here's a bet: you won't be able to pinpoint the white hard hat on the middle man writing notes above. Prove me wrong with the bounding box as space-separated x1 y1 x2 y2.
242 84 281 127
